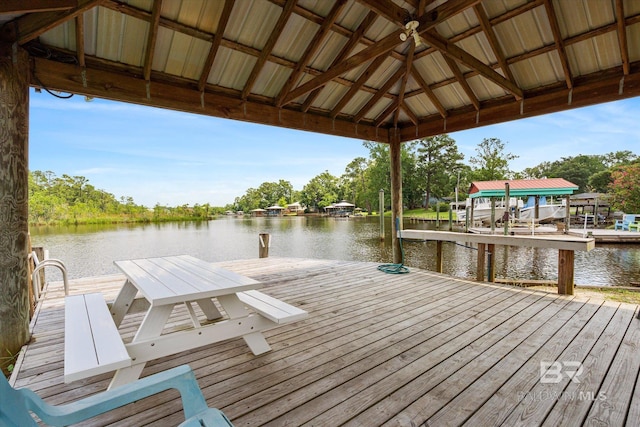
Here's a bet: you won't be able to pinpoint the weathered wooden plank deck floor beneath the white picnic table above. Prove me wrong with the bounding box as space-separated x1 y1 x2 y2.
14 258 640 426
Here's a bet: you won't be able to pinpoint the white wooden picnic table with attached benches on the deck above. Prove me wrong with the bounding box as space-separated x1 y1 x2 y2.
65 255 307 389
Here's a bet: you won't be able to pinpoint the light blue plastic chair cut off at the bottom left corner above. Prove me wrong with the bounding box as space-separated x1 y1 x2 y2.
0 365 233 427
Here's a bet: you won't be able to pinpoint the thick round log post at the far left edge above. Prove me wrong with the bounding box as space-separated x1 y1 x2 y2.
0 41 31 375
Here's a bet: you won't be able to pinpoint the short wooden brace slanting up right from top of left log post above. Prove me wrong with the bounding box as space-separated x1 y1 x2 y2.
14 0 102 45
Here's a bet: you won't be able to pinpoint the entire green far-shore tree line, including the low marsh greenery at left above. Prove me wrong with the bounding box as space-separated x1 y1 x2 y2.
29 134 640 225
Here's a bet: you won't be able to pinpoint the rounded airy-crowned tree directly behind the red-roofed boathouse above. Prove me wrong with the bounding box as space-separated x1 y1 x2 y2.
469 138 518 181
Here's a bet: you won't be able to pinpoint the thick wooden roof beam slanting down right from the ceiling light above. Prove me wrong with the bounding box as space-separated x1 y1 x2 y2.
420 30 523 100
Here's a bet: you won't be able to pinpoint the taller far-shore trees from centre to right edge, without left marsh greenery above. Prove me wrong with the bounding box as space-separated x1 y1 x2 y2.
232 138 640 212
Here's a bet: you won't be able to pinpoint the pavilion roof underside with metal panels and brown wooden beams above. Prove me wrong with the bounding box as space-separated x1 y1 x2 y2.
0 0 640 142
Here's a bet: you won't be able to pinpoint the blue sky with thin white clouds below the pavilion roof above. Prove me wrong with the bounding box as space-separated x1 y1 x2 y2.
29 91 640 207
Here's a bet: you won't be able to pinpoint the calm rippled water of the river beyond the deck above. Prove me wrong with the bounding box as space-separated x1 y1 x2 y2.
31 217 640 285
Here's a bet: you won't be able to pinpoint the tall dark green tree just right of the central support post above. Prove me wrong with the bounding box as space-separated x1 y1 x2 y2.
418 134 464 208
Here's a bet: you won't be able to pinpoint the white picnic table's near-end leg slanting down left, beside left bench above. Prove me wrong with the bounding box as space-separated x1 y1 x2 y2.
109 304 173 390
